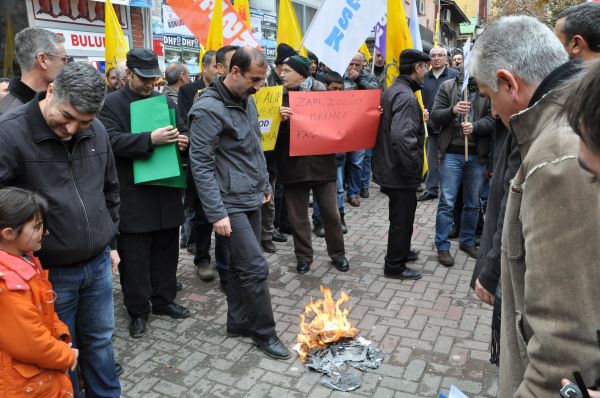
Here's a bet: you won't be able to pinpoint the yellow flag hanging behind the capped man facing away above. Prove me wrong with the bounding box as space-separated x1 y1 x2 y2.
385 0 428 175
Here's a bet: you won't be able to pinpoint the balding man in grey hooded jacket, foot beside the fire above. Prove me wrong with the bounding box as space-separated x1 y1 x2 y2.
188 47 290 359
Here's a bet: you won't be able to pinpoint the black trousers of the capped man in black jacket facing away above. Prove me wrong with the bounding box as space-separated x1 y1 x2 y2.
381 188 417 269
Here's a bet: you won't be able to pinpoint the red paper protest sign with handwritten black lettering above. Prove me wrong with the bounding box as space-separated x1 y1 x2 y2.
289 90 381 156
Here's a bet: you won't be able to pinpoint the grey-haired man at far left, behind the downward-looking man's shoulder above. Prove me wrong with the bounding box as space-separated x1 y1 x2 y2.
0 28 68 115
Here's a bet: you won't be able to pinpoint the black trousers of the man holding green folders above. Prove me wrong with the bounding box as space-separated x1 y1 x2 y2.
117 228 179 316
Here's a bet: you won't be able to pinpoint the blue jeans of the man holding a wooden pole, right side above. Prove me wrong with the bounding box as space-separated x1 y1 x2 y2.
435 153 485 250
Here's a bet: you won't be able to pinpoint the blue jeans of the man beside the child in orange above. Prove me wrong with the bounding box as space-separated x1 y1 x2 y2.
49 246 121 398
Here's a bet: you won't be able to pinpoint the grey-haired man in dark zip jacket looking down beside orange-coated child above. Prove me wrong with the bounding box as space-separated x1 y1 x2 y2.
0 62 121 398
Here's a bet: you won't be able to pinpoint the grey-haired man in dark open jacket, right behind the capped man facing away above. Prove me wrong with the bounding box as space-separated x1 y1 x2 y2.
417 46 458 202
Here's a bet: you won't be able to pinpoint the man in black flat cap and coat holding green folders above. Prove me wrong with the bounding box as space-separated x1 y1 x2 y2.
98 48 190 338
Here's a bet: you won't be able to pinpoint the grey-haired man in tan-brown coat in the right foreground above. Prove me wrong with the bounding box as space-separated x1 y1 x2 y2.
469 16 600 397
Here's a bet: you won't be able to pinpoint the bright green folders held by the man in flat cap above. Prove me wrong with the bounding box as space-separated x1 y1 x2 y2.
130 95 186 188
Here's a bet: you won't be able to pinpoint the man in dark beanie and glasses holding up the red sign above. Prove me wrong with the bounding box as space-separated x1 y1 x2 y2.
275 55 350 274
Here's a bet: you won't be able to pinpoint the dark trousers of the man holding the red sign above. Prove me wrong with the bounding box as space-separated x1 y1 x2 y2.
284 181 345 261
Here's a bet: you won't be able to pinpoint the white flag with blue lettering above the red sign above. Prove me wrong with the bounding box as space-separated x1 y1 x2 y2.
303 0 387 74
